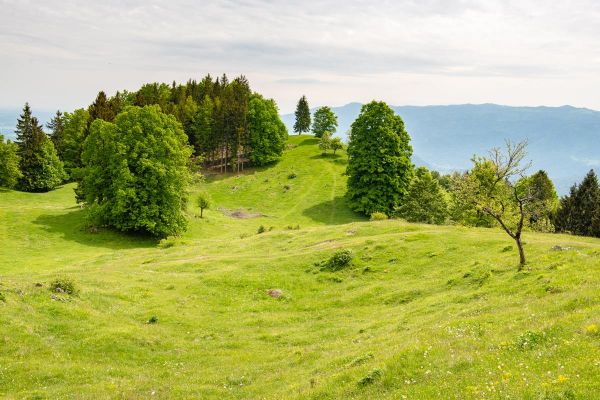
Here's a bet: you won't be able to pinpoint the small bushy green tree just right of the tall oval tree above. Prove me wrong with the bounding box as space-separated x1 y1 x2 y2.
398 167 448 225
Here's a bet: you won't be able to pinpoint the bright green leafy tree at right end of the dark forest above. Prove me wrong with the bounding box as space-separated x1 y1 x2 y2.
248 94 288 166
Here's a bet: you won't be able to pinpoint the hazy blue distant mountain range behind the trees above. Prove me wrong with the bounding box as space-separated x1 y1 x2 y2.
282 103 600 194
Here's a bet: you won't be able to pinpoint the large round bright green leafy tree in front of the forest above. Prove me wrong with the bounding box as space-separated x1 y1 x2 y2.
78 106 192 237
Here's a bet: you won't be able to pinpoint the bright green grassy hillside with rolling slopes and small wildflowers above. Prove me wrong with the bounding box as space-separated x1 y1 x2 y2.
0 136 600 399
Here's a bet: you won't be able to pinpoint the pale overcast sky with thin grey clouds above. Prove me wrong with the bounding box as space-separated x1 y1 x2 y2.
0 0 600 112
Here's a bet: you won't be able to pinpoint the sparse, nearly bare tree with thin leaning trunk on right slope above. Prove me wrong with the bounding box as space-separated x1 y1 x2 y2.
470 141 536 270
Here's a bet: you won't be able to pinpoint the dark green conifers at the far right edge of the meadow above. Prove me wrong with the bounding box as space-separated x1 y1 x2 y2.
555 170 600 237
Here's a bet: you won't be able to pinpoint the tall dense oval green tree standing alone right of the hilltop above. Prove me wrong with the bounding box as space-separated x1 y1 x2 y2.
346 101 413 215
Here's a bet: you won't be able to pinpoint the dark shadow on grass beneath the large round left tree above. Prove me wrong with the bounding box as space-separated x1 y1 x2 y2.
33 210 158 250
